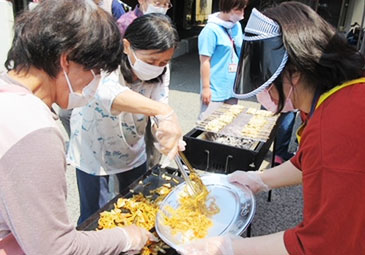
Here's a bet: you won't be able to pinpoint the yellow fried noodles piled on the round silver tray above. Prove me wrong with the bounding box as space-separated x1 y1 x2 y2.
163 172 219 240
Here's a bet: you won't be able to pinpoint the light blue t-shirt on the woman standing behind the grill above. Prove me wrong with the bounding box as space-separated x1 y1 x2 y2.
198 23 243 101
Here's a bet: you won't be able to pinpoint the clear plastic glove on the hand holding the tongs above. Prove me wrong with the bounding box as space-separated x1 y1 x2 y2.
155 111 185 156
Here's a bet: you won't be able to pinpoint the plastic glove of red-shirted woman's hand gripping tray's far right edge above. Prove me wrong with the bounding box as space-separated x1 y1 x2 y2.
228 170 271 193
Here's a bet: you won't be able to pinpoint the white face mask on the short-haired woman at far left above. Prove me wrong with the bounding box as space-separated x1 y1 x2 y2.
63 70 101 109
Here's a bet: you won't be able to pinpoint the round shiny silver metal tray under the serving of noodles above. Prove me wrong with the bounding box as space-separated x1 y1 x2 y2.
155 174 256 249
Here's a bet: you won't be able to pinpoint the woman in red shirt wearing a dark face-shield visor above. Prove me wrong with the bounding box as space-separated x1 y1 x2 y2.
178 1 365 255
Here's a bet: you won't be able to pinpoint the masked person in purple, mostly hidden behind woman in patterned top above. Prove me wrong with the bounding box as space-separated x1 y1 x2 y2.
117 0 172 37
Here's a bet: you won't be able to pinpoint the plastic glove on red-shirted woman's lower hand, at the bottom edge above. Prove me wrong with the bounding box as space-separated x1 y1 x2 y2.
177 235 236 255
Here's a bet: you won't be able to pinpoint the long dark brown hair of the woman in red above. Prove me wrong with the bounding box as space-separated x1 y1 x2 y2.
263 1 365 111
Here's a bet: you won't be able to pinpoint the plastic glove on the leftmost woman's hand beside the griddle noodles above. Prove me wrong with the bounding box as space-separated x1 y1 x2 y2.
119 225 157 254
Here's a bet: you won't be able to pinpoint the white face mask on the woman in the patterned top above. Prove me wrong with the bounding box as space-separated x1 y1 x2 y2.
127 50 166 81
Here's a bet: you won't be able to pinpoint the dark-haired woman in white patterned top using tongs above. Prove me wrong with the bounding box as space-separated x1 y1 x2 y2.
68 14 182 223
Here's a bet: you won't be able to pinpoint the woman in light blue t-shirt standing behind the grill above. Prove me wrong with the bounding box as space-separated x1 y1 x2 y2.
198 0 247 119
